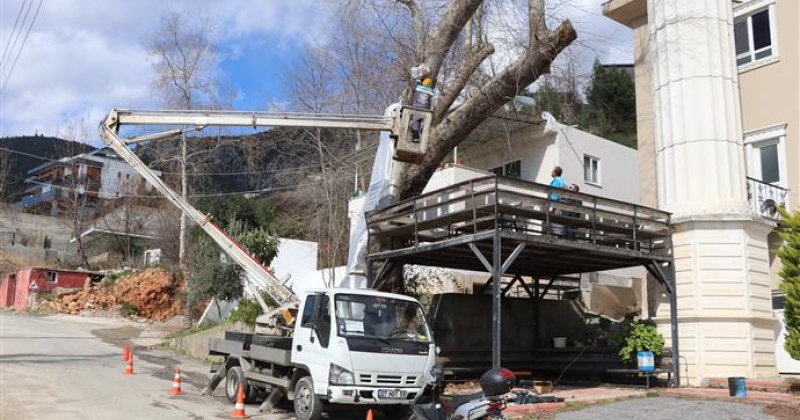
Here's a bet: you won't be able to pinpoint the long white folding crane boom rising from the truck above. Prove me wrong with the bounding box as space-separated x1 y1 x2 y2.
100 108 429 313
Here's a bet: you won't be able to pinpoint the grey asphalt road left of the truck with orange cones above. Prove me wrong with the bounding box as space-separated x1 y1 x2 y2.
0 312 292 420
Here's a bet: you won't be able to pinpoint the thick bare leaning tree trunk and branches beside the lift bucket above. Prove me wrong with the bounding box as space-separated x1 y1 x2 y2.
395 0 577 199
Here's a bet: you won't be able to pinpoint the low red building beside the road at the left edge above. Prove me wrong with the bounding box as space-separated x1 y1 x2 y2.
0 267 103 310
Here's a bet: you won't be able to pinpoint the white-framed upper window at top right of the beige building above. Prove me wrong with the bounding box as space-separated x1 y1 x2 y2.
733 1 778 68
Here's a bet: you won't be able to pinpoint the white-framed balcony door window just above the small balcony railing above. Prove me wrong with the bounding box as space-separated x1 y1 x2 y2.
745 124 786 187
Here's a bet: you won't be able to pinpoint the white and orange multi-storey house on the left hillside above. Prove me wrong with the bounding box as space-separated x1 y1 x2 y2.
17 148 160 217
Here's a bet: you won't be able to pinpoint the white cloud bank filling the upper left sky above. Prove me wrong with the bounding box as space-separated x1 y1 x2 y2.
0 0 324 141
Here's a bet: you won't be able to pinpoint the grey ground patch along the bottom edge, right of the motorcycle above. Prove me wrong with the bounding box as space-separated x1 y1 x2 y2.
556 397 775 420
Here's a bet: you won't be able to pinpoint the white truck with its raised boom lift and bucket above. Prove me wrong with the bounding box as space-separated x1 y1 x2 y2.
100 105 436 420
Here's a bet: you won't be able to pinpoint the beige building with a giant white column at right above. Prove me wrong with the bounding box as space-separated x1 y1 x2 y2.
603 0 800 378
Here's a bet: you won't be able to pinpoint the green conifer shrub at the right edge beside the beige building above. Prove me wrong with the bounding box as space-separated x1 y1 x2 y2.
778 209 800 360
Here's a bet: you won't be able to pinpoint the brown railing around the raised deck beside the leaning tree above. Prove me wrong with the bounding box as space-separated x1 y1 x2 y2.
367 176 671 255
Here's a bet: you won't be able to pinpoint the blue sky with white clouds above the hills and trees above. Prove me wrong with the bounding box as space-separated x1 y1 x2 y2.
0 0 632 143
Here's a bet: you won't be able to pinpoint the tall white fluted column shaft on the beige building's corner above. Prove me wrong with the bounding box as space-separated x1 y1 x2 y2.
648 0 748 216
